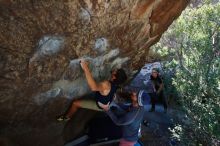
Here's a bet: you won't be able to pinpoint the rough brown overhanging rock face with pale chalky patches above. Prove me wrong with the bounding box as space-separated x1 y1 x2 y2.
0 0 189 146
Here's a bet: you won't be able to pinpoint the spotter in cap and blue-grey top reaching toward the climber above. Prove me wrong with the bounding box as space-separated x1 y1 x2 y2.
98 91 150 146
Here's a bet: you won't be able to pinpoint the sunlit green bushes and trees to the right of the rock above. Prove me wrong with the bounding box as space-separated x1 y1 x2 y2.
154 3 220 144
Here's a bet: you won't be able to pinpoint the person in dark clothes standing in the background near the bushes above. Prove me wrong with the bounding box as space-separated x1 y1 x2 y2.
149 68 167 112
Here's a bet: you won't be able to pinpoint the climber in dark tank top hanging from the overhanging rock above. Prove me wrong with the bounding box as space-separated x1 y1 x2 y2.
57 60 127 121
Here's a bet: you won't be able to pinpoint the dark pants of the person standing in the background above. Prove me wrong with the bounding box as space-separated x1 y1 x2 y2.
149 91 167 109
